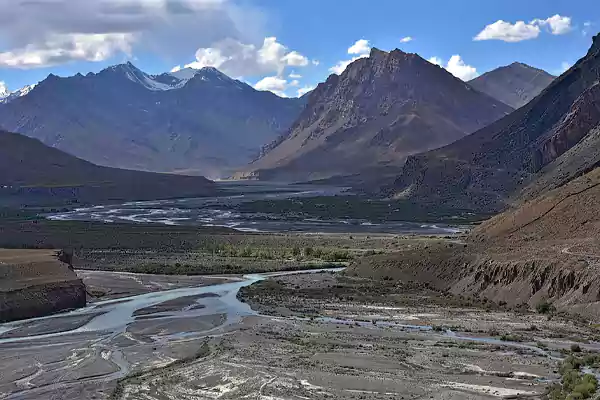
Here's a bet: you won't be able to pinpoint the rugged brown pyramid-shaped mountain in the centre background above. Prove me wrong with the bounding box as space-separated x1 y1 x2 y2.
239 49 512 181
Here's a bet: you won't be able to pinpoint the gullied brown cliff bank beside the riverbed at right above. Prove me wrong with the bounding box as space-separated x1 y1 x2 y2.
347 242 600 319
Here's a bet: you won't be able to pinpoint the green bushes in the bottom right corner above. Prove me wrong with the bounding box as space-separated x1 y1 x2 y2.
548 355 600 400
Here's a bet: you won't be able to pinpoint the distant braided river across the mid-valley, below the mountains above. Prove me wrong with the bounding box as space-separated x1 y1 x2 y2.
46 182 462 235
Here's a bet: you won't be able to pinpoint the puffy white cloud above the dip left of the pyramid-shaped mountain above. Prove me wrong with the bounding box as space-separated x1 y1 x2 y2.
185 37 309 76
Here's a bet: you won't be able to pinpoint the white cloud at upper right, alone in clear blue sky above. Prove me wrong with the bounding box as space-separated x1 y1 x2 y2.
474 14 572 43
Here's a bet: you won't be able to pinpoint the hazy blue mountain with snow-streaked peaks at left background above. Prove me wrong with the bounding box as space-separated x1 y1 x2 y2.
0 63 304 177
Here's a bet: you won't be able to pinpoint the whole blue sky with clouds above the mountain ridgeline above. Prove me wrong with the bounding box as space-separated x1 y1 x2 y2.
0 0 600 97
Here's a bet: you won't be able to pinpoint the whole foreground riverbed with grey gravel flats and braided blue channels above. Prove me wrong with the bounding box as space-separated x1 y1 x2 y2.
0 271 598 400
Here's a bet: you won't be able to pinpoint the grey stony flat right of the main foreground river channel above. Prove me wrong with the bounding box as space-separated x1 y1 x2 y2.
112 273 598 399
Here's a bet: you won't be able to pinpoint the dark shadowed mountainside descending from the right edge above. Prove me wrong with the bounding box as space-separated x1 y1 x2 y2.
387 35 600 211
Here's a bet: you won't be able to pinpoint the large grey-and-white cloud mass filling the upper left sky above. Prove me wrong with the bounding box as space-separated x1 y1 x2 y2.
0 0 263 68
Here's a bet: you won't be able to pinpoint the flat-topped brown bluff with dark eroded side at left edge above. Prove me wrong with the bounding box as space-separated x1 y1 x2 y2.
0 249 86 322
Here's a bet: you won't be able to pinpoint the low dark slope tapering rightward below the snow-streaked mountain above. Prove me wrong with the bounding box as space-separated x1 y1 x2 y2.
0 131 216 203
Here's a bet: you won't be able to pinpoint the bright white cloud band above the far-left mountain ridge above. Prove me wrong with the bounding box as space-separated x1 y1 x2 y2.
0 33 135 69
